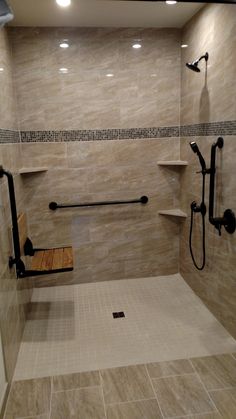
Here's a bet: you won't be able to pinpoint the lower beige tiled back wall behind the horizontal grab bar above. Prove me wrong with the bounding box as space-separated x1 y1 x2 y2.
21 138 179 286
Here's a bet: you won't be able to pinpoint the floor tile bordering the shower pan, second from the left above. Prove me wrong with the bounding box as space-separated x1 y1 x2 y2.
52 371 100 391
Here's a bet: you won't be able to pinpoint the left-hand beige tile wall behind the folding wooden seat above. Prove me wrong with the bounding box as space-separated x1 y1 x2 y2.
0 29 30 381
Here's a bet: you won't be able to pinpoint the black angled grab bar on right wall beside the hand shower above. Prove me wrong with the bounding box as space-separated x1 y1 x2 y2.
209 137 236 236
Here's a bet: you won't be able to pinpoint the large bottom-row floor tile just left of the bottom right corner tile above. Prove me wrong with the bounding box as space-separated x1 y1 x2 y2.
152 374 215 417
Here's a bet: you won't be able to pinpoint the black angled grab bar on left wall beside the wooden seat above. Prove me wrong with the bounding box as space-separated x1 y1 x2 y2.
0 166 24 277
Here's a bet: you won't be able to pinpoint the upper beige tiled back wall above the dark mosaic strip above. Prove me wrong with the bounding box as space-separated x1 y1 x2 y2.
7 28 180 130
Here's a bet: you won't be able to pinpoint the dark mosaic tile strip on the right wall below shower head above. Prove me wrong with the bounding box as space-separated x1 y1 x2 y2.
180 120 236 137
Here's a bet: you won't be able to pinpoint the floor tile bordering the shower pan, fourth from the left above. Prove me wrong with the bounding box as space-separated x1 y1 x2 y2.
147 359 195 378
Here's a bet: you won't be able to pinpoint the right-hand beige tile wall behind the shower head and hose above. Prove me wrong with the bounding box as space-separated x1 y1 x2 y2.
180 5 236 336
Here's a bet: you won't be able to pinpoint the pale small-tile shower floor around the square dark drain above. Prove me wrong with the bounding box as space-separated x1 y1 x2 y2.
14 274 236 380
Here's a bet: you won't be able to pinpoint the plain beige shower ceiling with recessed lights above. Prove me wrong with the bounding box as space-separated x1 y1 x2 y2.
7 0 204 28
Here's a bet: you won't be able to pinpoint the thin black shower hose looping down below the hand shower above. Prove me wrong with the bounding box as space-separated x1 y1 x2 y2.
189 173 206 271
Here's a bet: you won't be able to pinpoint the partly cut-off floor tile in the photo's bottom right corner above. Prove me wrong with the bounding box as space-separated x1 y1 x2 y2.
210 389 236 419
